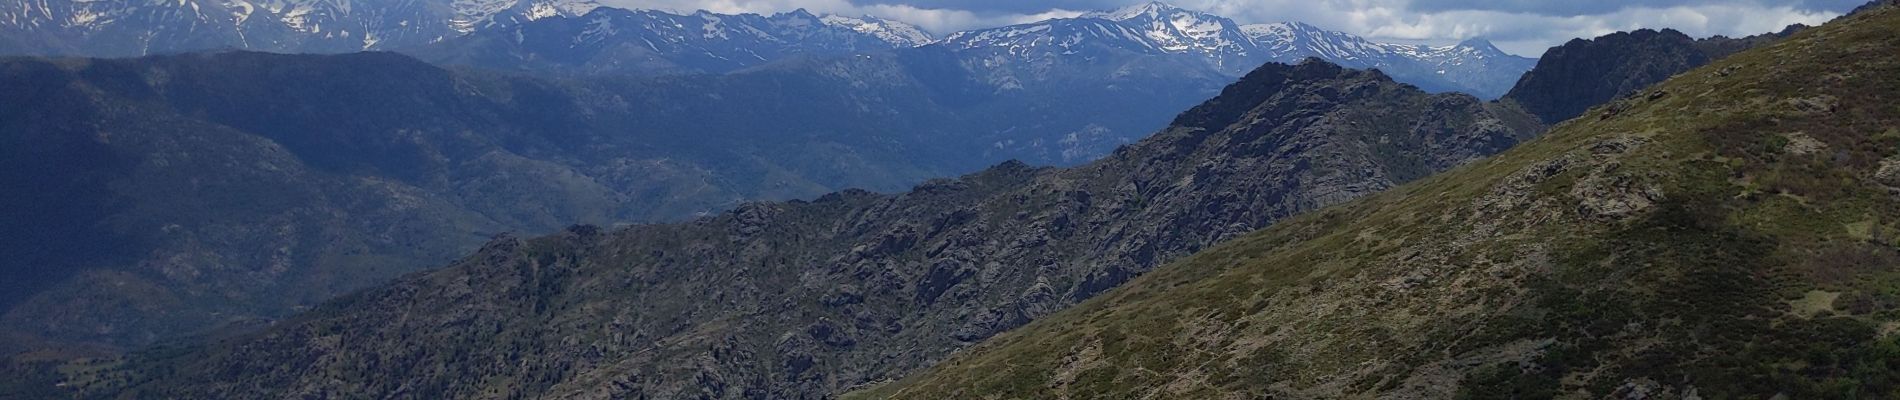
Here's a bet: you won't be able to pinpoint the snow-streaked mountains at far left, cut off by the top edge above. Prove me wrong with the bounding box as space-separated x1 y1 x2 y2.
0 0 599 57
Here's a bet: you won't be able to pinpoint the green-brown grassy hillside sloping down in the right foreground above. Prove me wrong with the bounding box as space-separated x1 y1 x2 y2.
851 8 1900 398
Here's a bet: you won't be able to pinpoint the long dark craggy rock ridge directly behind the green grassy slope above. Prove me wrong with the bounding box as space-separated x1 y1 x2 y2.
59 63 1533 398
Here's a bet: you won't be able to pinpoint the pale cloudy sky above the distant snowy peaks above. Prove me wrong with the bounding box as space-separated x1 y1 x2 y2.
600 0 1866 57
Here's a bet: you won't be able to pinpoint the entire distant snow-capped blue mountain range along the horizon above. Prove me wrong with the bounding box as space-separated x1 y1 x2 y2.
0 0 1535 97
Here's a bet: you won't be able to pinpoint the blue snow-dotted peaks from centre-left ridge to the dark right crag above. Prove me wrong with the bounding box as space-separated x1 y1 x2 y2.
410 2 1535 99
